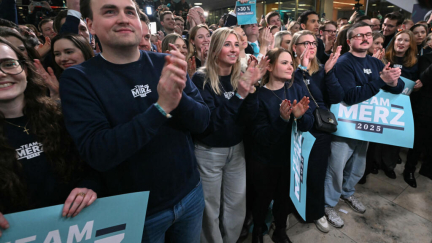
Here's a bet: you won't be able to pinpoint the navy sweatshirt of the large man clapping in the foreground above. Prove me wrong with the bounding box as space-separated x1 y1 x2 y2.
60 51 210 215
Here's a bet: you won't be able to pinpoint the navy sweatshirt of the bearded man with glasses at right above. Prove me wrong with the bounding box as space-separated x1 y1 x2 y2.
334 52 405 105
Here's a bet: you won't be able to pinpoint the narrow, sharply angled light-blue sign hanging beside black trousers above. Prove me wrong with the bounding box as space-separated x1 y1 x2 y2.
290 121 316 220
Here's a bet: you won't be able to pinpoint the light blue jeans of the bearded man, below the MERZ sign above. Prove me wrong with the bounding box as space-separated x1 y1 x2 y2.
324 136 368 207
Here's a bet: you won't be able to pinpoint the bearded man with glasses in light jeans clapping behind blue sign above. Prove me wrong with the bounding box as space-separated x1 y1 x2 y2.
324 22 405 228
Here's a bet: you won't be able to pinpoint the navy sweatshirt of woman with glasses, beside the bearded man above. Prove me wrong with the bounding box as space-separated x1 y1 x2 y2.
294 64 345 111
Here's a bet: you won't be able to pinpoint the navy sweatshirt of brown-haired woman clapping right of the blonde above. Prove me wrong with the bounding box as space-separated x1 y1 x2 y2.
251 82 314 167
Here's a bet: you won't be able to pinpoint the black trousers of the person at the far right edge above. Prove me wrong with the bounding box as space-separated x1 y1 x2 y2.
405 114 432 173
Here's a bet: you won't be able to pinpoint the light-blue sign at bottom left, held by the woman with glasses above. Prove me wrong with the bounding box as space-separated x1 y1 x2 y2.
0 192 149 243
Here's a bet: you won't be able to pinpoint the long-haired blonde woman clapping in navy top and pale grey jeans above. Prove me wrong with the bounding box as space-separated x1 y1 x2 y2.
192 28 266 243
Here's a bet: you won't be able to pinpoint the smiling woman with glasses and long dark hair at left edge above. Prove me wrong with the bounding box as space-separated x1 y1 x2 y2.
0 37 97 235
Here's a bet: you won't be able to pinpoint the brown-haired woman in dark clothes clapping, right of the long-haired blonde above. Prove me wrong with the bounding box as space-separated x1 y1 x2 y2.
248 48 314 242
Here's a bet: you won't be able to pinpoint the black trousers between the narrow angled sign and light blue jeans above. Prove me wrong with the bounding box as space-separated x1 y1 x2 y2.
306 130 332 222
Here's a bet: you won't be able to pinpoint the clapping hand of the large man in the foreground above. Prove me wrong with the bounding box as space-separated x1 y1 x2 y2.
157 44 187 113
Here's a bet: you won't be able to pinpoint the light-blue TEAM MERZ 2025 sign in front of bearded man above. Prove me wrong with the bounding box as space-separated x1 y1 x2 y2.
330 90 414 148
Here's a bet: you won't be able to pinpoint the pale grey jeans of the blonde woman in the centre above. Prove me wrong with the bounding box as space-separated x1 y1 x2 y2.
195 142 246 243
